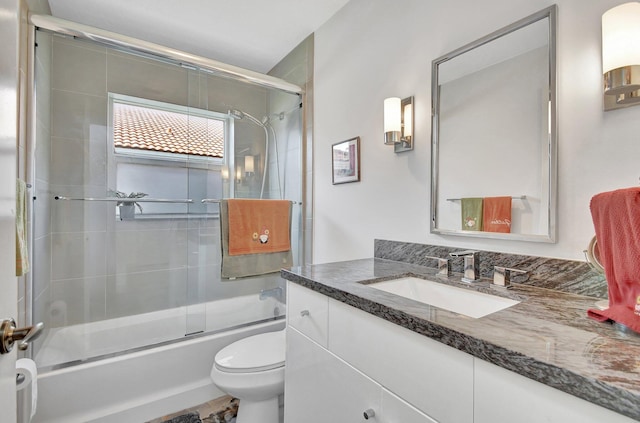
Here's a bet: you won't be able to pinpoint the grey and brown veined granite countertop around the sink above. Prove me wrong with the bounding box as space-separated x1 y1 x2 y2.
282 258 640 420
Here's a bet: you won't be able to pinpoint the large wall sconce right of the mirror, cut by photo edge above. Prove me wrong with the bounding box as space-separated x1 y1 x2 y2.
602 2 640 110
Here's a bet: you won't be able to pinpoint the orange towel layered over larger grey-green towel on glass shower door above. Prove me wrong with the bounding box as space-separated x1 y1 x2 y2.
228 199 291 256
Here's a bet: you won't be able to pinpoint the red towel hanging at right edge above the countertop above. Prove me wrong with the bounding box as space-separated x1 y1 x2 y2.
587 187 640 332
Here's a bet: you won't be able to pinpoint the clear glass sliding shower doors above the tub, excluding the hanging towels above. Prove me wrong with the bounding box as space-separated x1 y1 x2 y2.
30 31 302 368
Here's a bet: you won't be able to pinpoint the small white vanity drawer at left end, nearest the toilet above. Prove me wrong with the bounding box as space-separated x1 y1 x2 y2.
287 282 329 348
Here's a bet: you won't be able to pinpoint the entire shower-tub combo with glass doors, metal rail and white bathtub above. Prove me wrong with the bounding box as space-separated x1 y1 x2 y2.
25 15 302 423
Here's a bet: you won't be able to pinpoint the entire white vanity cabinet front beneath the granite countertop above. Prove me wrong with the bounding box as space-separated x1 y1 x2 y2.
285 282 635 423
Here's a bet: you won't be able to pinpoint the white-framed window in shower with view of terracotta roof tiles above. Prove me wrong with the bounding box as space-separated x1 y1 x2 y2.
107 93 229 220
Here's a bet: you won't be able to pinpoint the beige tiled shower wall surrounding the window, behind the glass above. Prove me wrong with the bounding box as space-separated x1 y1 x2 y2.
34 33 292 327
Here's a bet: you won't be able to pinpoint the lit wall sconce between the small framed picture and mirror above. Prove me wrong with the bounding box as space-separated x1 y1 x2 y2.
384 96 413 153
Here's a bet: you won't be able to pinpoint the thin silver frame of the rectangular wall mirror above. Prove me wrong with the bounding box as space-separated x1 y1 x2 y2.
431 5 558 243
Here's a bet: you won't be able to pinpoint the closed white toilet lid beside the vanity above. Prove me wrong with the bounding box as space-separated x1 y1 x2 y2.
215 330 285 373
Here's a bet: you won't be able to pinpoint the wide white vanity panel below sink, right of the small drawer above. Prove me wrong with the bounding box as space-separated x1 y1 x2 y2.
329 300 473 423
